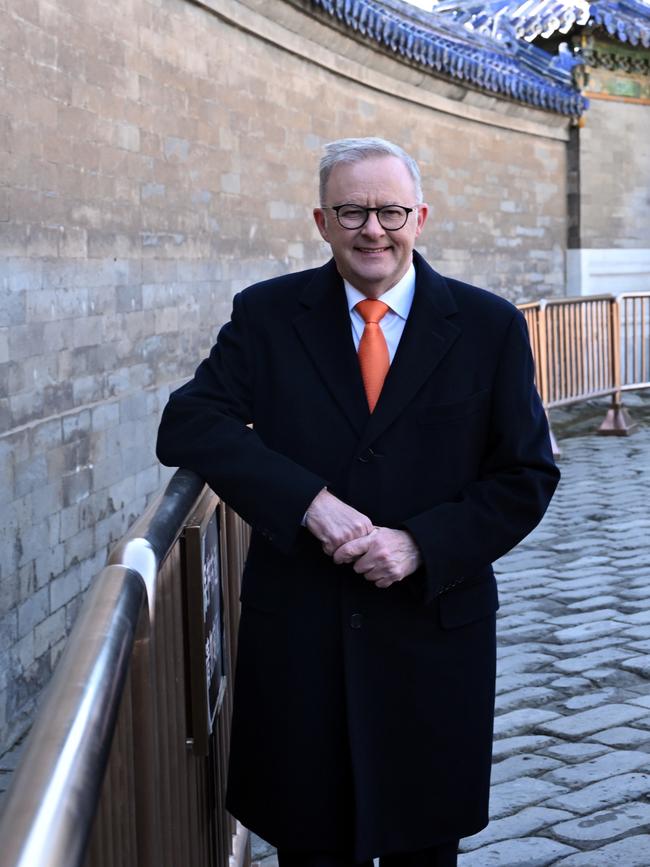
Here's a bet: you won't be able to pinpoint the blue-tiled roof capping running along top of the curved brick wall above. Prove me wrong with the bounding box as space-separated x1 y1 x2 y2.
308 0 587 117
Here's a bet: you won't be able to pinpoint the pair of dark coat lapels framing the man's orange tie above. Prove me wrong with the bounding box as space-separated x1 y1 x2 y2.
294 253 460 440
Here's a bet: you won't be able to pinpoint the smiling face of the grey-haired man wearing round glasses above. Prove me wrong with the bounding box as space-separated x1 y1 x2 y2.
314 156 429 298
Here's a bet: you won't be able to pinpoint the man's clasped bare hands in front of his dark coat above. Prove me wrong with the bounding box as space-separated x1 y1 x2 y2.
305 488 422 588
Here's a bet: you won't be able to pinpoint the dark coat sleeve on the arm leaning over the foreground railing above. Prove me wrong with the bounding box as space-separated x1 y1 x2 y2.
156 295 327 552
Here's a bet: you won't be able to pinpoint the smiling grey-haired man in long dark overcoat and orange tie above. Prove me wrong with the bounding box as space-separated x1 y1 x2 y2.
158 139 559 867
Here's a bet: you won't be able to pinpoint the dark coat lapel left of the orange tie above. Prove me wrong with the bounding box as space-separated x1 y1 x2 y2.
293 259 369 436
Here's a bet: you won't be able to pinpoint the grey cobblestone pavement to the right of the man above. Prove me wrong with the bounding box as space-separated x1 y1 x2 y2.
254 424 650 867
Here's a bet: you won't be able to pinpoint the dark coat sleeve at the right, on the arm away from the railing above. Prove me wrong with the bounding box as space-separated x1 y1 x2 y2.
403 311 560 601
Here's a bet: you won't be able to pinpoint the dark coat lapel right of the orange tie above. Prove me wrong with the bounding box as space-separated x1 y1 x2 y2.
360 253 460 449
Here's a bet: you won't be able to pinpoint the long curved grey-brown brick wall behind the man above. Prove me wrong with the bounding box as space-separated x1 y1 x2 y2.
0 0 566 751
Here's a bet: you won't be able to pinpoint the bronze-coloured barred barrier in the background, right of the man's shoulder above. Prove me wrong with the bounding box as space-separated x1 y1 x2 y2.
519 292 650 454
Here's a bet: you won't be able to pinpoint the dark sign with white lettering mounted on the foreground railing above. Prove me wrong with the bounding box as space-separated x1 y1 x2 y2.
184 492 226 755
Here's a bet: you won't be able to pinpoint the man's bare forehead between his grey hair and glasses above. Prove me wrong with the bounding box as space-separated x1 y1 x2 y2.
327 156 415 205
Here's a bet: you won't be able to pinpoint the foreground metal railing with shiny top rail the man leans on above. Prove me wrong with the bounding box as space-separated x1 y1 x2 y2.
0 470 249 867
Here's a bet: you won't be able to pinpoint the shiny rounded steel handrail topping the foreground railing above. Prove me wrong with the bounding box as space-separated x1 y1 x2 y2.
0 470 203 867
